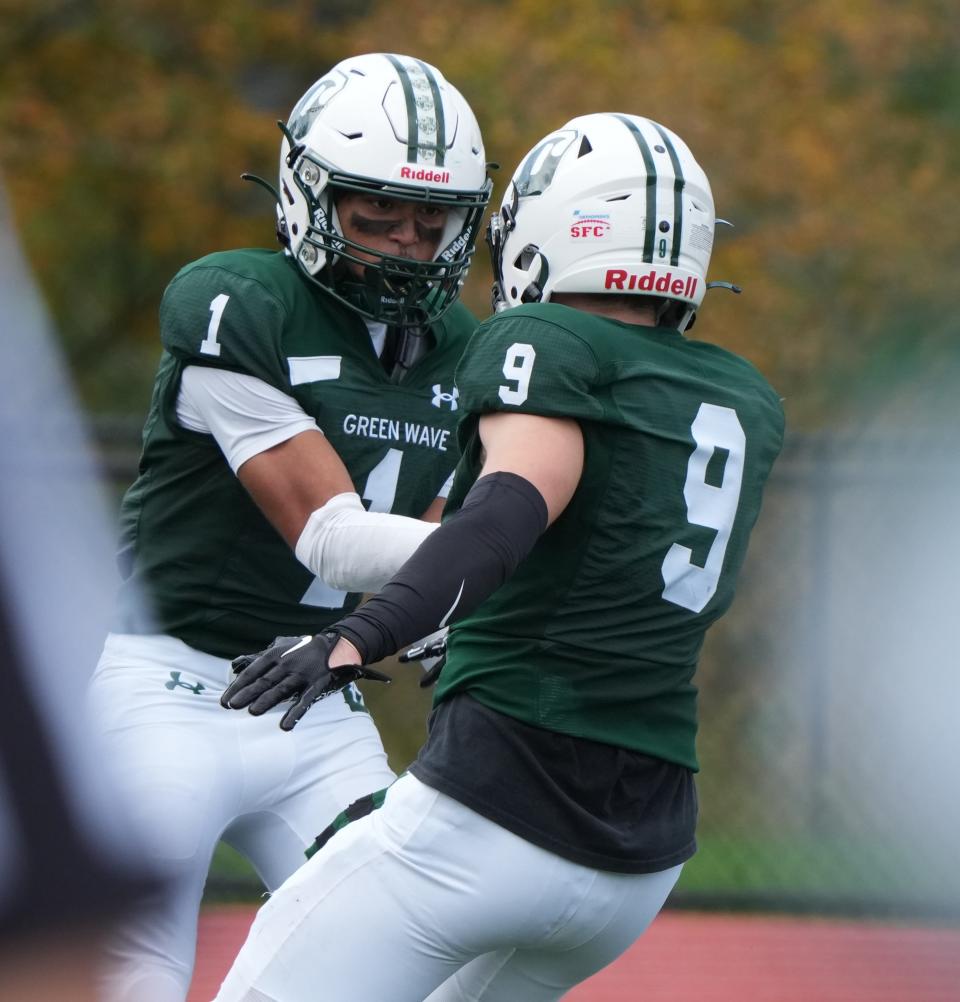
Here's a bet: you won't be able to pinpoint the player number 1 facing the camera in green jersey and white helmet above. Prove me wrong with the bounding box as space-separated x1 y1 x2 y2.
86 53 491 1002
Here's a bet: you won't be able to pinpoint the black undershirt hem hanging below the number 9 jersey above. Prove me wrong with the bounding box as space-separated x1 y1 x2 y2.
409 692 697 874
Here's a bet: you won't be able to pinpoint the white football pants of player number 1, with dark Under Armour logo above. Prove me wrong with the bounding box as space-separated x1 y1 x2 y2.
90 634 394 1002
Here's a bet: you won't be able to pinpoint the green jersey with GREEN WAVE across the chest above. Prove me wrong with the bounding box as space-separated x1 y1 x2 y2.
115 249 476 657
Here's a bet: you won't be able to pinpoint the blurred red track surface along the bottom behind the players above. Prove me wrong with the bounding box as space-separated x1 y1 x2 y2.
187 906 960 1002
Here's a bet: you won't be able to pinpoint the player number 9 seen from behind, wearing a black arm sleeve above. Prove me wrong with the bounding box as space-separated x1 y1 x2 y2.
217 113 784 1002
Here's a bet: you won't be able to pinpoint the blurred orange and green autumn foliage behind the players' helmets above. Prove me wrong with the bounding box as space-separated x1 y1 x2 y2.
0 0 960 420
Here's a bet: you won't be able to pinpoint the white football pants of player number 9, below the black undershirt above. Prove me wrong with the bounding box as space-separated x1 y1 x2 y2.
215 763 681 1002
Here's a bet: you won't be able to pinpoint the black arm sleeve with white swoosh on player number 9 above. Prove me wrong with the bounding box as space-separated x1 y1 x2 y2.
333 473 547 664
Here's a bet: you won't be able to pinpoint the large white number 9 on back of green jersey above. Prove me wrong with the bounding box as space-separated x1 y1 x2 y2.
662 403 747 612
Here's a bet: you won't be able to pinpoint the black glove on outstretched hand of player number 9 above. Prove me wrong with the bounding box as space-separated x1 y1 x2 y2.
220 630 391 730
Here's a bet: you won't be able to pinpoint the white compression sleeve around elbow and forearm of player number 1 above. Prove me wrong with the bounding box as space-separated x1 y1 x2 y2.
296 493 439 592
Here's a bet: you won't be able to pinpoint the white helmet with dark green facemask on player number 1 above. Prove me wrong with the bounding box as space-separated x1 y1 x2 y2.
278 53 492 326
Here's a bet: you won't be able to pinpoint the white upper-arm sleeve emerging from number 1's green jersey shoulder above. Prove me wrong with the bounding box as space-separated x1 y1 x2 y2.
176 366 320 473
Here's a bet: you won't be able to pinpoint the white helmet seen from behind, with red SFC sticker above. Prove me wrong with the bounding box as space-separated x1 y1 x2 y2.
487 113 715 331
